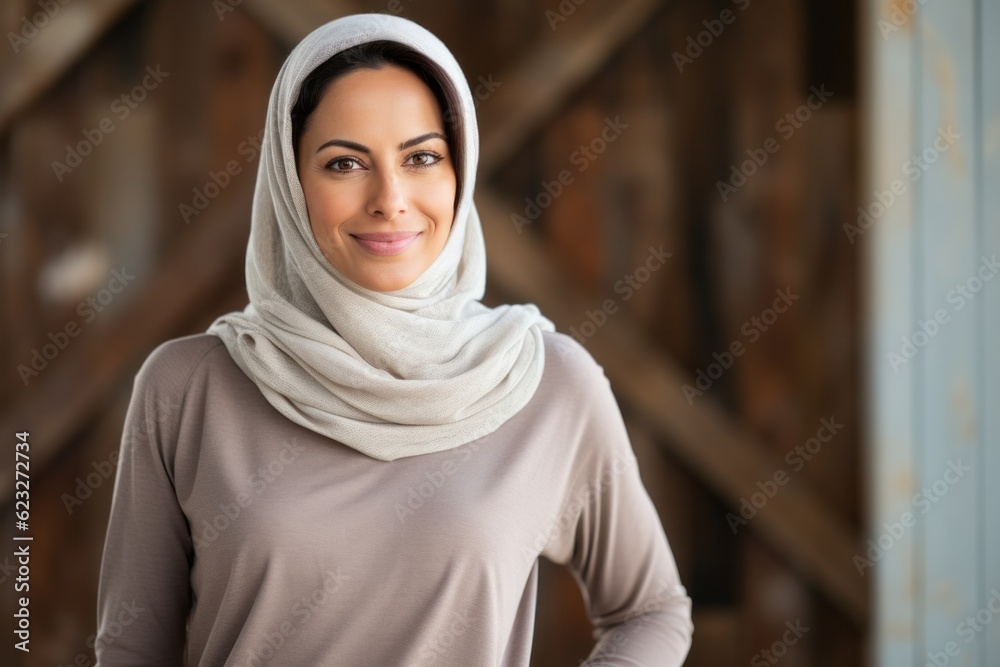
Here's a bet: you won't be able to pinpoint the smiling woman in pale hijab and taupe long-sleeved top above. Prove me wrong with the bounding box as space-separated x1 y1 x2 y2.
97 15 692 667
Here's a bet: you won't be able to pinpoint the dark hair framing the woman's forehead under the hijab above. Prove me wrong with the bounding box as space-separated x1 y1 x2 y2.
291 40 465 207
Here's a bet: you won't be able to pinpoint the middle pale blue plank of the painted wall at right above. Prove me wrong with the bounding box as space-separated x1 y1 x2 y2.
916 0 980 667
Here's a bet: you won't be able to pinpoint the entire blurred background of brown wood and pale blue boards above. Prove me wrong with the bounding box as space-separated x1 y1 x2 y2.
0 0 1000 667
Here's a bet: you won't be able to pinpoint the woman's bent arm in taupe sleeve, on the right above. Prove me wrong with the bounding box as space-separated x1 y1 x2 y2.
543 352 694 667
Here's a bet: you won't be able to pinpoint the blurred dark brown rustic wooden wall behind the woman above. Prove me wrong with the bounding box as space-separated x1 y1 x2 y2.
0 0 868 667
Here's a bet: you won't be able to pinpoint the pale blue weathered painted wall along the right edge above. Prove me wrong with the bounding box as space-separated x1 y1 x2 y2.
855 0 1000 667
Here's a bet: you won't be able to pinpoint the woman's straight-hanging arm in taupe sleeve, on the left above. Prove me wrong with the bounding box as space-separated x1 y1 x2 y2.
94 348 192 667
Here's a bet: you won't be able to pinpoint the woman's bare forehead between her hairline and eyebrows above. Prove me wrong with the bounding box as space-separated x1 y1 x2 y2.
310 66 443 138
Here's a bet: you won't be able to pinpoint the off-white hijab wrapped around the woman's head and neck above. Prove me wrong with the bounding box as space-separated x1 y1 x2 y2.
208 14 555 461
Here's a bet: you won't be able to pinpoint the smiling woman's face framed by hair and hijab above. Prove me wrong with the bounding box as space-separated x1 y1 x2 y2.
298 67 456 292
